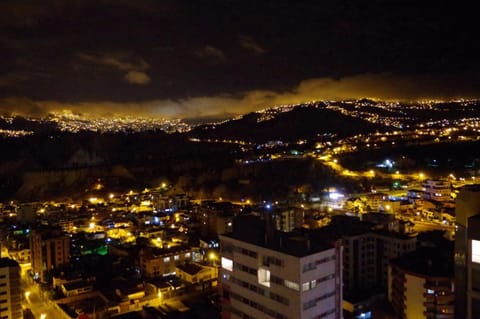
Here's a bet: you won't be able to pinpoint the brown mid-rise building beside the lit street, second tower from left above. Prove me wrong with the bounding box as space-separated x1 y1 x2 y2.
30 228 70 281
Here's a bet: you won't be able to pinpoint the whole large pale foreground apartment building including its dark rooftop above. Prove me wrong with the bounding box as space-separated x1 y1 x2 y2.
219 215 343 319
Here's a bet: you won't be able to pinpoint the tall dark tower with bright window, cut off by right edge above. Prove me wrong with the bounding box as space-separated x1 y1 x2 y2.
454 185 480 319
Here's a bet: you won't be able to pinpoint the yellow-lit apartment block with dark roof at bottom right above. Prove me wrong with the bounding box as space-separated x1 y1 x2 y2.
388 247 456 319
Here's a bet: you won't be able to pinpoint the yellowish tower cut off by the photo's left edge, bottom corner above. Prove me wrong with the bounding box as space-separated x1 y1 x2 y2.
0 258 23 319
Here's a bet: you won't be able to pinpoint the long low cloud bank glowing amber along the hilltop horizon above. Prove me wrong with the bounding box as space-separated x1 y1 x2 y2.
0 74 480 121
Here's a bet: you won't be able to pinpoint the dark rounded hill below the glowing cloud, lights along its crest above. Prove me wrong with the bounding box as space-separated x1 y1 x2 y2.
188 105 385 142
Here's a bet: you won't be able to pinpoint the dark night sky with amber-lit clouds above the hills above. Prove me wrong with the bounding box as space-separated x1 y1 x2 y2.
0 0 480 118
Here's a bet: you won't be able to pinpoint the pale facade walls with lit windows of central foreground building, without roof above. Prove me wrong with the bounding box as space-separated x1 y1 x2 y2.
220 236 342 319
